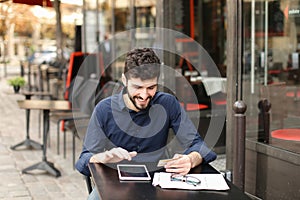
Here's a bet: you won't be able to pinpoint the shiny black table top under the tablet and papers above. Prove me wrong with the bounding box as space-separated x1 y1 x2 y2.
89 163 250 200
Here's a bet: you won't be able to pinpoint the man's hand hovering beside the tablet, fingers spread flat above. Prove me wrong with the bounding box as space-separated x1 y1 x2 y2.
90 147 137 163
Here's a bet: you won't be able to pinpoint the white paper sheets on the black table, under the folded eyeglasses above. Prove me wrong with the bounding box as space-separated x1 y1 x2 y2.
152 172 229 190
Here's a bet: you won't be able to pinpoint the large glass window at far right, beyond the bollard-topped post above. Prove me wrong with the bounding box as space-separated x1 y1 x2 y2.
243 0 300 155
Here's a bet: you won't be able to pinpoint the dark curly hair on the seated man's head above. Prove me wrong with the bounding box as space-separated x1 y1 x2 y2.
124 48 160 80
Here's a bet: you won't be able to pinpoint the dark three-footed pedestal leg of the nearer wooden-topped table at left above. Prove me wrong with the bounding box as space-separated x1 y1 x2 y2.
22 110 61 177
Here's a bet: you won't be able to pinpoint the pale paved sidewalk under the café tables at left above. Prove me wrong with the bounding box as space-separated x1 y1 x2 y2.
0 67 88 200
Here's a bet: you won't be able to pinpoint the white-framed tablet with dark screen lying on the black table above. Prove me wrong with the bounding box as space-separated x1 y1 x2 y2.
117 164 151 181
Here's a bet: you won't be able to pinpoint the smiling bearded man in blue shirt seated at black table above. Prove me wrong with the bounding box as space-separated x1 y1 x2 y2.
76 48 216 199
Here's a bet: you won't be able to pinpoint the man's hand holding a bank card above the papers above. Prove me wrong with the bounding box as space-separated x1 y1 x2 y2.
165 152 202 176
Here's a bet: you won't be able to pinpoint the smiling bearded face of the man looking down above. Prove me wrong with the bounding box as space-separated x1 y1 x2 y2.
126 77 157 110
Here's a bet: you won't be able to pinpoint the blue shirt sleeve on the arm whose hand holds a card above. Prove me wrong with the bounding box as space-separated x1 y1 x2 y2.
169 97 217 163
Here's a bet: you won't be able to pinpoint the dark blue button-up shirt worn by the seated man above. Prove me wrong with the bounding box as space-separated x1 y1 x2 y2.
76 91 216 176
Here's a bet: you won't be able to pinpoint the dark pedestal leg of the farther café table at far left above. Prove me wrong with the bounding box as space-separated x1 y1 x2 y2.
10 109 42 150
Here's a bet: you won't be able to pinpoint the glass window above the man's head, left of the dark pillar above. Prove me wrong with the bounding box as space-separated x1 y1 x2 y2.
83 0 156 79
